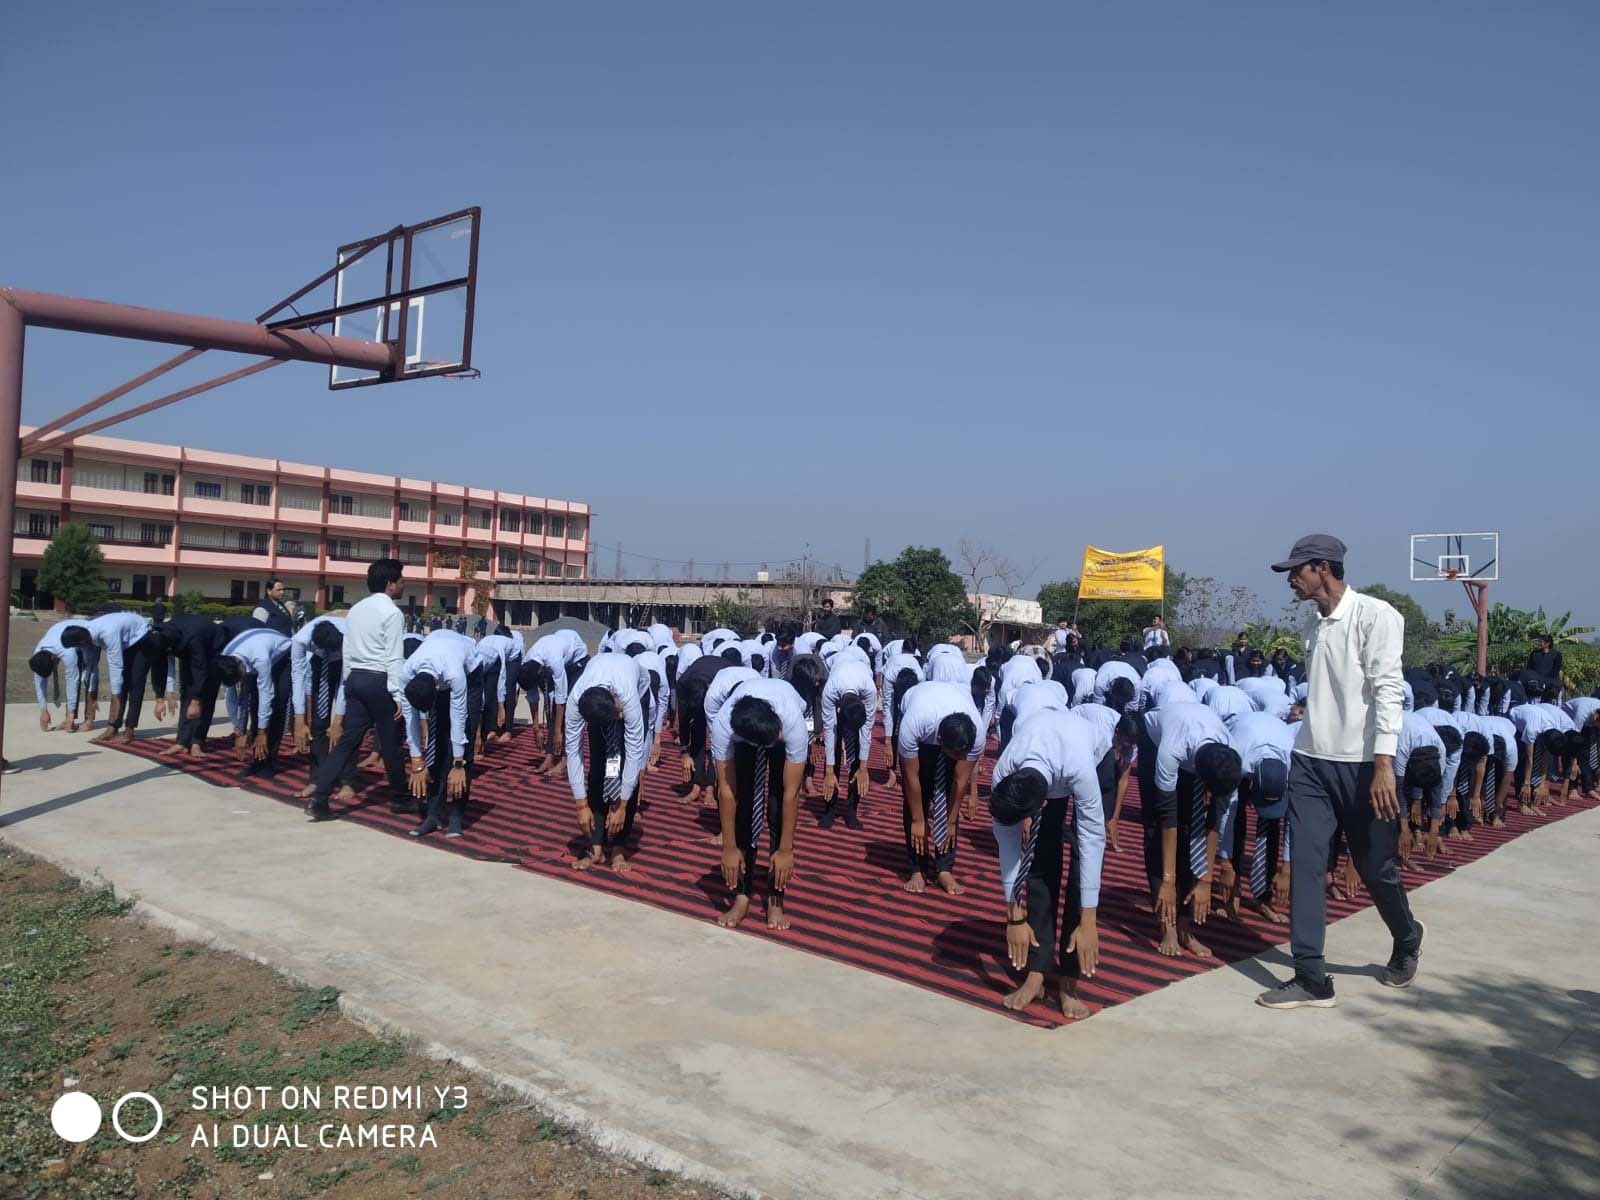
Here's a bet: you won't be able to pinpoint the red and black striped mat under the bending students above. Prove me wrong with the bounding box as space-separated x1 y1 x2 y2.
106 726 1594 1026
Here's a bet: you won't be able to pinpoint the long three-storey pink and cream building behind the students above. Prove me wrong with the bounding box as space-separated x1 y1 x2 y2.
11 426 590 610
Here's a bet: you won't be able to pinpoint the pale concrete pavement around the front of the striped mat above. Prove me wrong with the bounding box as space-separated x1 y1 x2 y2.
0 707 1600 1200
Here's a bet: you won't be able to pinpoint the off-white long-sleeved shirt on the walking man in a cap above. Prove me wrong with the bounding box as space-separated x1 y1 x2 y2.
1294 587 1405 763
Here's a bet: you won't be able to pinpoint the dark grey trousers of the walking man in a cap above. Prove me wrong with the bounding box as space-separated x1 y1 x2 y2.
1288 754 1421 981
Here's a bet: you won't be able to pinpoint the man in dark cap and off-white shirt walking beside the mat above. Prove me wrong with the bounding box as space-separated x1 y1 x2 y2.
1256 533 1424 1008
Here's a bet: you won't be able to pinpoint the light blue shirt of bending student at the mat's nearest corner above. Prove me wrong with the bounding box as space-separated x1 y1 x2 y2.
994 710 1106 909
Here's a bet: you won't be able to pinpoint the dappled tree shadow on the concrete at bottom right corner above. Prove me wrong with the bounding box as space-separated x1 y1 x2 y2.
1344 958 1600 1198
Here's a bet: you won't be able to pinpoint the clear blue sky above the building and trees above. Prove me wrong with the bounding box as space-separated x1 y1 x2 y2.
0 0 1600 624
